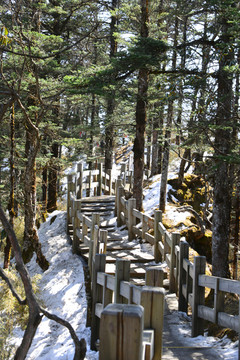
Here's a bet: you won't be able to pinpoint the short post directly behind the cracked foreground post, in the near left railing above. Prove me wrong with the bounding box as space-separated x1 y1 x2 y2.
114 259 131 304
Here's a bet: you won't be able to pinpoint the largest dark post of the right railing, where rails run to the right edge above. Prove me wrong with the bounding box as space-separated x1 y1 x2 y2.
192 256 206 337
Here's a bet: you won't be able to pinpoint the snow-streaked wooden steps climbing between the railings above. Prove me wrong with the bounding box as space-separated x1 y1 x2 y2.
76 195 157 283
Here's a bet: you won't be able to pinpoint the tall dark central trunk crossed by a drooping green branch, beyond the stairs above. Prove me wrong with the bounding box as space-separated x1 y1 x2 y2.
133 0 149 210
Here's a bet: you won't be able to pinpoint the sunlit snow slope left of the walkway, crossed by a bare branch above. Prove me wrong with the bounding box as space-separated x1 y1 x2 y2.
9 211 98 360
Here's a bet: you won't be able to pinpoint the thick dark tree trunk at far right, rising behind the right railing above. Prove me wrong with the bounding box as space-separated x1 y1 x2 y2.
212 18 233 277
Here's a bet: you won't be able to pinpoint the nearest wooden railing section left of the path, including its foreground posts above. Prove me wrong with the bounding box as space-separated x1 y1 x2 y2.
91 254 165 360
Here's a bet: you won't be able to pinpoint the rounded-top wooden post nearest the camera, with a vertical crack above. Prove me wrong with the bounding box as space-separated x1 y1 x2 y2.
99 304 143 360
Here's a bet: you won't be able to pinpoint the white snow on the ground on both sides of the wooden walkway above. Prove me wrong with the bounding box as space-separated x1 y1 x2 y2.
7 170 238 360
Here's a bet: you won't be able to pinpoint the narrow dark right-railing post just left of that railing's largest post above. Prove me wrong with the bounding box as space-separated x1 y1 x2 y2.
178 240 189 313
